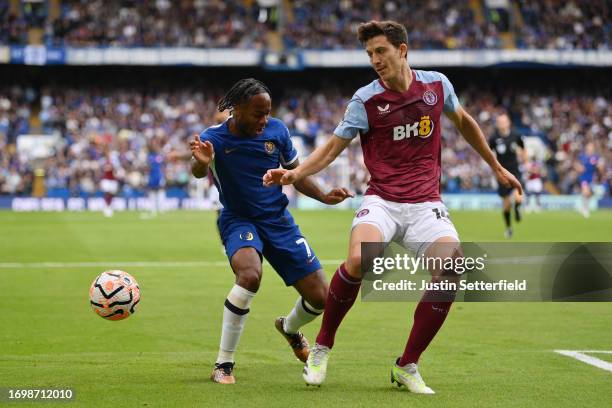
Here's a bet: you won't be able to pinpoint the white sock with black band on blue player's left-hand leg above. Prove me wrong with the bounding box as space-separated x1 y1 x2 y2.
217 285 255 364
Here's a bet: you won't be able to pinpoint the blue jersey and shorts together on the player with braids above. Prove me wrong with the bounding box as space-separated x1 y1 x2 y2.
200 118 321 286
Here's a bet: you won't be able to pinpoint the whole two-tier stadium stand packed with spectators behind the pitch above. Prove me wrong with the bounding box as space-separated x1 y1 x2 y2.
0 0 612 204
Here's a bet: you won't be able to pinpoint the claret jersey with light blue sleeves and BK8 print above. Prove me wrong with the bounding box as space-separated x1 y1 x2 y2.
334 70 461 203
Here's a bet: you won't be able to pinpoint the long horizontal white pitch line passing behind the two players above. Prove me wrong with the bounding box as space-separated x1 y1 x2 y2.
0 259 343 269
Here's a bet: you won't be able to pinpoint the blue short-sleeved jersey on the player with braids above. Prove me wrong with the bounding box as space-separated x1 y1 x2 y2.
200 118 297 218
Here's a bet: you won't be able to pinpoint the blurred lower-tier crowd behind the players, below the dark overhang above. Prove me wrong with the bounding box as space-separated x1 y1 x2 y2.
0 83 612 195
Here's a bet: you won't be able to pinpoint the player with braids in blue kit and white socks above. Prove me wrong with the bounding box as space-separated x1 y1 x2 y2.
190 78 352 384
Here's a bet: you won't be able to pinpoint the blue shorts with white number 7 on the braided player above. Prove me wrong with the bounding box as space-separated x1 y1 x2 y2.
217 210 321 286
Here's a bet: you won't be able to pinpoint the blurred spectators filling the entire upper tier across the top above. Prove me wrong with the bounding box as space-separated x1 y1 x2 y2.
0 0 612 49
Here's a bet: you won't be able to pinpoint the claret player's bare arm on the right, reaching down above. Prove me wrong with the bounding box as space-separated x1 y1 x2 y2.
445 106 523 194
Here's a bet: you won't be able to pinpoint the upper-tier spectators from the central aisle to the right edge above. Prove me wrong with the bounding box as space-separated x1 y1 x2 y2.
284 0 612 49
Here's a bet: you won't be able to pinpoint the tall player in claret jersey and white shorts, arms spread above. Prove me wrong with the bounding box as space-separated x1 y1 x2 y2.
263 21 521 394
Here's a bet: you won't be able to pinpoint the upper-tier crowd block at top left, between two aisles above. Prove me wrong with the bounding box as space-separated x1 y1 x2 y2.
45 0 268 48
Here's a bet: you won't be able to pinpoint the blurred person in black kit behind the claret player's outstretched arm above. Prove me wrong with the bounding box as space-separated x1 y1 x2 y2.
489 113 526 239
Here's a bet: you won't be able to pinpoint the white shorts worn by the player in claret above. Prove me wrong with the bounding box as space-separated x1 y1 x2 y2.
352 195 459 256
